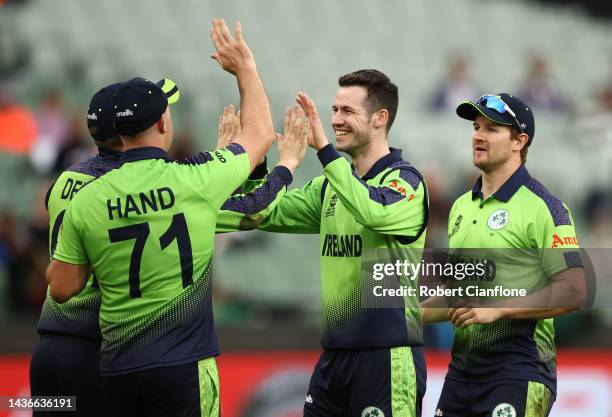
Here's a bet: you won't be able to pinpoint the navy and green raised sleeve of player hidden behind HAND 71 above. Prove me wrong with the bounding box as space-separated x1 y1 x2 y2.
216 166 293 233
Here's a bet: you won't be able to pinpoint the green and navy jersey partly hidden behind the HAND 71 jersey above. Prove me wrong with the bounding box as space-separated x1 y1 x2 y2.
37 149 121 340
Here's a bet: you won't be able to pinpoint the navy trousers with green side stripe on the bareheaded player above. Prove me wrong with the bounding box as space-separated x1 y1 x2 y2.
304 346 426 417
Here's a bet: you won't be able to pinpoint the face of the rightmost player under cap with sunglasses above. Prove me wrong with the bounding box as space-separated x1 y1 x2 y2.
472 116 522 172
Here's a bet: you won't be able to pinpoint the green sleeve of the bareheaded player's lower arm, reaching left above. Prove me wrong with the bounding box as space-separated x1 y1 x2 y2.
257 176 325 233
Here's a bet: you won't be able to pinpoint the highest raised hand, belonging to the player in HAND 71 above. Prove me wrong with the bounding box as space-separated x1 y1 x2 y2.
210 19 256 75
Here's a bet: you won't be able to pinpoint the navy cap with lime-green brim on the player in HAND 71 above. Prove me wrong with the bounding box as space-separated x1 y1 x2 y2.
113 77 179 136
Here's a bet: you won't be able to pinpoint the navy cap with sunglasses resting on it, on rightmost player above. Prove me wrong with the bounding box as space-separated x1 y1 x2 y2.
457 93 535 146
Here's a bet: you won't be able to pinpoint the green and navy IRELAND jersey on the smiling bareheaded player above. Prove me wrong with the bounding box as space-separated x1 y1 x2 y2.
259 145 428 349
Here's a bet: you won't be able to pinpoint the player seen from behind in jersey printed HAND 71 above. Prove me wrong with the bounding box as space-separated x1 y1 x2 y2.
47 20 306 416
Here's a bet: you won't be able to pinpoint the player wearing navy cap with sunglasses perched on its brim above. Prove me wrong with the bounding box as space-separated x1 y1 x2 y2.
422 93 586 417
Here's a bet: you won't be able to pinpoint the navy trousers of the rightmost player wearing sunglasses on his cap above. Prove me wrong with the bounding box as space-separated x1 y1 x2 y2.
434 379 555 417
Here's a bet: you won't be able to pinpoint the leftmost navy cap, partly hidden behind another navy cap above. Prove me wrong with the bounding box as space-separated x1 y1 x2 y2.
87 83 121 142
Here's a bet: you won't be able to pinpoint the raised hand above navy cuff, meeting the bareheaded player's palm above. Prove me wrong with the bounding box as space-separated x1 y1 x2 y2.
276 106 312 172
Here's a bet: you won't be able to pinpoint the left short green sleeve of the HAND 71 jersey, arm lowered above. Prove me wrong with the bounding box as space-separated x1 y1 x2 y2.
53 203 89 265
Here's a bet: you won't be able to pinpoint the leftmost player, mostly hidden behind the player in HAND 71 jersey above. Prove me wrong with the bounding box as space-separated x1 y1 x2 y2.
30 79 294 417
